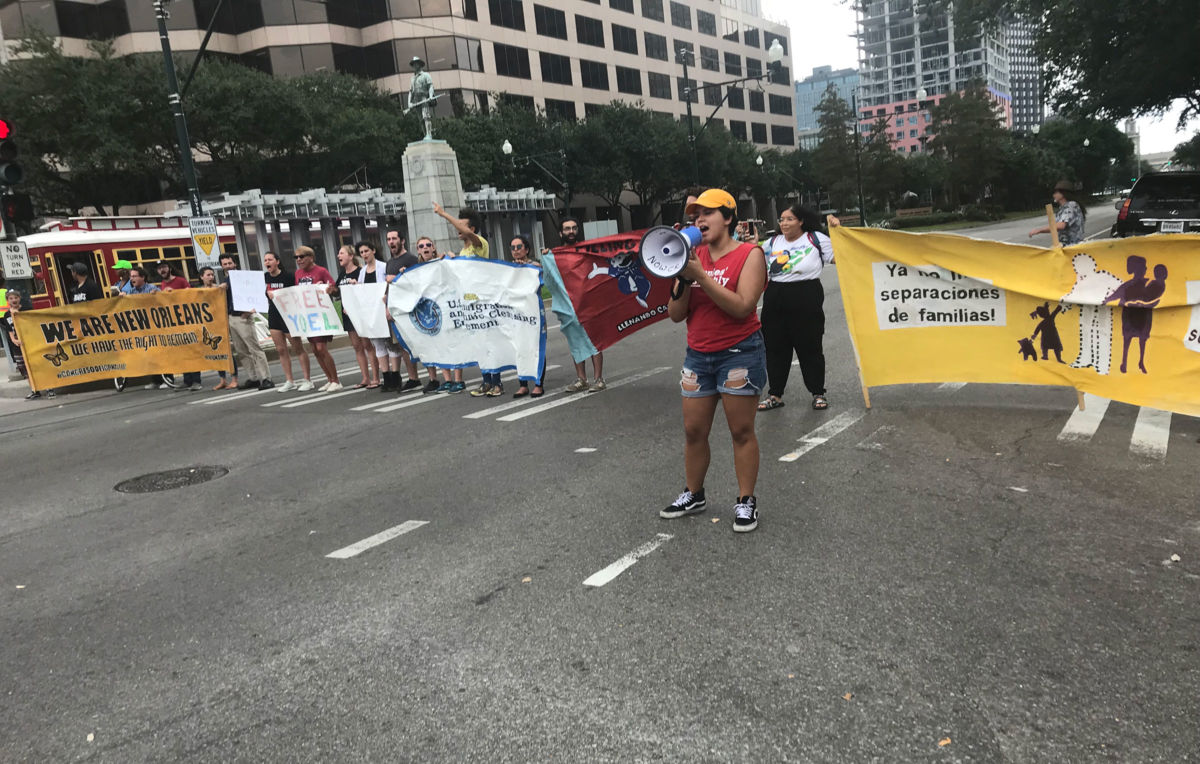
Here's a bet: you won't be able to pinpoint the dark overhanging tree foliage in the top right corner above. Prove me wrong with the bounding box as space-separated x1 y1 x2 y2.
920 0 1200 128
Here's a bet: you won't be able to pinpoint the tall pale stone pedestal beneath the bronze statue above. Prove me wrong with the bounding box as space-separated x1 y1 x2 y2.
403 139 463 254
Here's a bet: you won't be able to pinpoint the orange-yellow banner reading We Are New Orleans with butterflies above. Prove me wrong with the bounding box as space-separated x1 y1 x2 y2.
16 289 233 390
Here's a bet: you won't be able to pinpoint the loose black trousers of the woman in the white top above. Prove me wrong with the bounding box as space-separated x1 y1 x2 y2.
762 278 826 398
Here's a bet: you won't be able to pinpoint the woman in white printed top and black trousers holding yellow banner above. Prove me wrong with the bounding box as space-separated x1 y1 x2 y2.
758 204 833 411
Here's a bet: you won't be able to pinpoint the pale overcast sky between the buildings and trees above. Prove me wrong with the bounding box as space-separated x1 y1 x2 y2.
762 0 1200 154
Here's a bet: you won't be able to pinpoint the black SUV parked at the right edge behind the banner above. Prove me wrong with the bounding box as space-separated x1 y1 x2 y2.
1112 172 1200 236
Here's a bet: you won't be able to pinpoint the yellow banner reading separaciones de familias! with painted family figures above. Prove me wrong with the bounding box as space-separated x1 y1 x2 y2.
832 227 1200 416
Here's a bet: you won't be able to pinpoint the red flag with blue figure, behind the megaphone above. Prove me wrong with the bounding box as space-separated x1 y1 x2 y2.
553 230 674 350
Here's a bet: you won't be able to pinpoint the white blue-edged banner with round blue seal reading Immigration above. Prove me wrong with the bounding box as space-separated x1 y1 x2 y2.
388 258 546 379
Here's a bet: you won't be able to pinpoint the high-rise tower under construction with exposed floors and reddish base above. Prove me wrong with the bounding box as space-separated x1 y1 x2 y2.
856 0 1013 152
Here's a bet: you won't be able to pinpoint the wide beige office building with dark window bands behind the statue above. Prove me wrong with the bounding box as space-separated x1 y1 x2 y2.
0 0 796 149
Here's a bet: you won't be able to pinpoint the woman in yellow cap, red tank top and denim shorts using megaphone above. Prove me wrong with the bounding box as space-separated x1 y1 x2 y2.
659 188 767 533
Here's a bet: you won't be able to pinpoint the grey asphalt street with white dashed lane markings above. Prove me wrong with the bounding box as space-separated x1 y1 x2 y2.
0 203 1200 763
